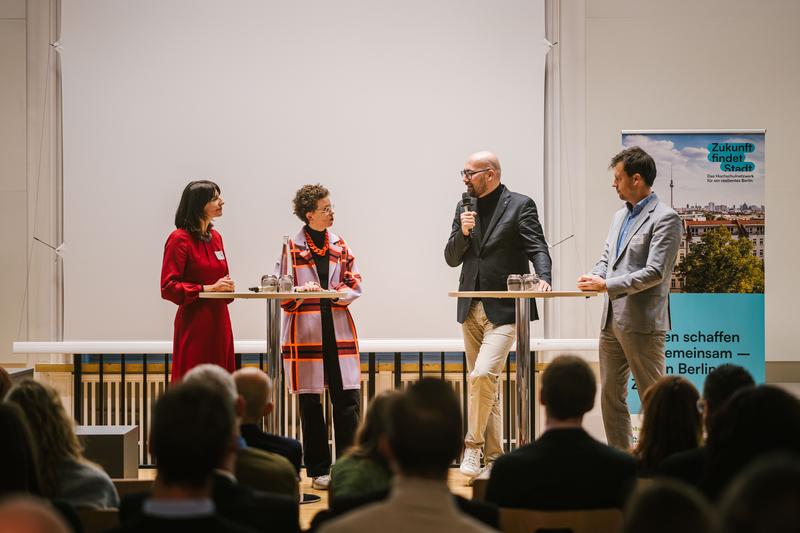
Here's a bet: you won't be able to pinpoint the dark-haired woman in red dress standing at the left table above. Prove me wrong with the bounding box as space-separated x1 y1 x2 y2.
161 180 235 382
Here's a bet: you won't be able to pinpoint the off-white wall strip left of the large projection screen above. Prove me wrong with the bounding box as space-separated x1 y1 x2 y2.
0 0 58 366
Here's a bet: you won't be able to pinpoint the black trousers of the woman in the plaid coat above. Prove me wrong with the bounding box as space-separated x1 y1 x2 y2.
300 305 361 477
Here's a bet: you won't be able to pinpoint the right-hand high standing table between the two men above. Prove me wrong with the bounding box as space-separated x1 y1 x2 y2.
447 291 598 446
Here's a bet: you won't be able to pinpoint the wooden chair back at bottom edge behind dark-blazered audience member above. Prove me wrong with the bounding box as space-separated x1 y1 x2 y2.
500 508 622 533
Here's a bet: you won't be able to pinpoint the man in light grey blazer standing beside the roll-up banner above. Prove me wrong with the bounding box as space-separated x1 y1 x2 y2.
578 146 682 449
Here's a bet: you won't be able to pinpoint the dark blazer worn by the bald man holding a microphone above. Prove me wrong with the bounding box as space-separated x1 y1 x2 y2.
444 188 552 326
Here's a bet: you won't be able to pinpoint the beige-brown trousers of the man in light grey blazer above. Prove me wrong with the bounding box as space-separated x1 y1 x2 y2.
600 309 666 450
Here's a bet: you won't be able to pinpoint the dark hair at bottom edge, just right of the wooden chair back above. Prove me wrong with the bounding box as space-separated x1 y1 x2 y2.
622 479 716 533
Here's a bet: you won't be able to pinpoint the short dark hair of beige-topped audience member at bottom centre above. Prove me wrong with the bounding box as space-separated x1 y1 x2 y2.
387 378 463 476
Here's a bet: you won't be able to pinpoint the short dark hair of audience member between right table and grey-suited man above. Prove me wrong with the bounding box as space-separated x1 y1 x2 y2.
541 355 597 420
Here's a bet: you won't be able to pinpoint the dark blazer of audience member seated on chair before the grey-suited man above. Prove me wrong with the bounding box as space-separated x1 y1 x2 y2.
486 428 636 511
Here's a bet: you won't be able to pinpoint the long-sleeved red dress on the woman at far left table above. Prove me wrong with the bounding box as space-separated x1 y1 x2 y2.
161 229 236 383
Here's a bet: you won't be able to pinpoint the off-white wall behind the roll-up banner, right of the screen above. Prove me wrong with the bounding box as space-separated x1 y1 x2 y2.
559 0 800 361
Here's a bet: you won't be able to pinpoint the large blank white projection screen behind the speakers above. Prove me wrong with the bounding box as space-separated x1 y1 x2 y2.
62 0 544 339
